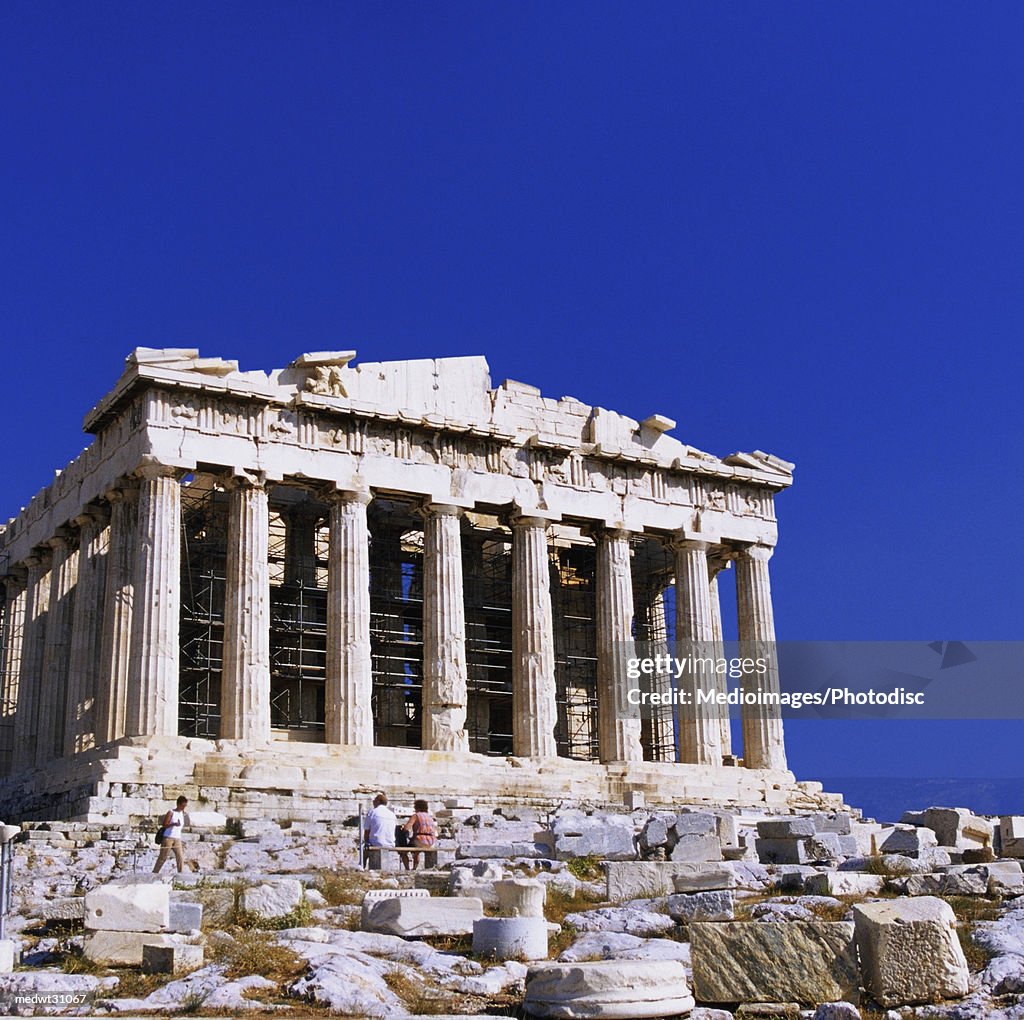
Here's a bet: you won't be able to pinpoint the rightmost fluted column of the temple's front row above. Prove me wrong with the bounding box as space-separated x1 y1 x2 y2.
736 546 785 769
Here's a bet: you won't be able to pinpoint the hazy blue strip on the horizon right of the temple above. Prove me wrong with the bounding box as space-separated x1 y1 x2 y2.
819 776 1024 821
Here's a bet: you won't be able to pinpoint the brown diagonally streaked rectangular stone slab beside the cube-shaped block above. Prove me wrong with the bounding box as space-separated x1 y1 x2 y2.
690 921 860 1006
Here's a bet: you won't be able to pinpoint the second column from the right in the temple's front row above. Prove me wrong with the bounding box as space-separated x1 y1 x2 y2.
673 539 725 765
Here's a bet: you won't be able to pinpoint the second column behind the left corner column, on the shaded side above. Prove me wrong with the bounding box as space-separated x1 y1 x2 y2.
63 510 108 755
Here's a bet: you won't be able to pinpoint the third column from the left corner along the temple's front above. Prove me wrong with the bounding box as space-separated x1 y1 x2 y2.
325 492 374 748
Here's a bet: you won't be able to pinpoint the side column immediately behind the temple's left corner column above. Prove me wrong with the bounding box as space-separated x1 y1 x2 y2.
95 479 138 745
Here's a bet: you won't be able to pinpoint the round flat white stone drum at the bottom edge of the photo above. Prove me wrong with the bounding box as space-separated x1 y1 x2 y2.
523 960 694 1018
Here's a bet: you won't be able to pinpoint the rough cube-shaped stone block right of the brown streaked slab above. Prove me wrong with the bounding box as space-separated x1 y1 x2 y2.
853 896 969 1009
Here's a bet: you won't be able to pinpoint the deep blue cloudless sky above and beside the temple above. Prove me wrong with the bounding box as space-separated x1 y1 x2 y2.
0 2 1024 798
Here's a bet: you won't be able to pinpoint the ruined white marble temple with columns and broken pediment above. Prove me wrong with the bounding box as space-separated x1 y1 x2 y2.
0 348 835 818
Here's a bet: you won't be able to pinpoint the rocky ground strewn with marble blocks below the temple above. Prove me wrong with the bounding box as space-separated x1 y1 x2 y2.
0 806 1024 1020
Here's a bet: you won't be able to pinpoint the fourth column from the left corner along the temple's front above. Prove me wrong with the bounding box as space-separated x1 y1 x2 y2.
423 504 469 751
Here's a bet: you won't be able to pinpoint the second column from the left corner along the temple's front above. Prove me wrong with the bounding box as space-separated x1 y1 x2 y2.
220 477 270 742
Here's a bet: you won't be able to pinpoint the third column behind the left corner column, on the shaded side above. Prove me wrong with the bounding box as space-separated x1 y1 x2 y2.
36 529 78 765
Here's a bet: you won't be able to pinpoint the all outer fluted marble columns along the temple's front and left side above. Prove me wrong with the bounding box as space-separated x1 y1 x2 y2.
4 465 785 768
